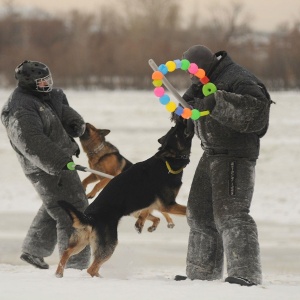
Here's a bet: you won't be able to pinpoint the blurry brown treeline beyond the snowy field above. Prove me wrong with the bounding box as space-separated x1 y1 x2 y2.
0 0 300 90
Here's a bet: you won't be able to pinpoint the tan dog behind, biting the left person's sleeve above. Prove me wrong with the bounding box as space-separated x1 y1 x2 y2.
80 123 175 233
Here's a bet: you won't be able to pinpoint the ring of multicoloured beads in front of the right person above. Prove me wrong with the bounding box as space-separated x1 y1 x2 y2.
152 59 217 120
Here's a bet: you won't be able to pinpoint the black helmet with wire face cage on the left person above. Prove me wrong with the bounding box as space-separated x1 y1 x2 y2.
15 60 53 93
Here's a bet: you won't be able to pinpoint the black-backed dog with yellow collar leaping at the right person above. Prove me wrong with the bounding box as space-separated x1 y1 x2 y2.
56 122 193 277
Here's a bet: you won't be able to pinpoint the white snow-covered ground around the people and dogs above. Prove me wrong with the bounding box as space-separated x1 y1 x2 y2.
0 90 300 300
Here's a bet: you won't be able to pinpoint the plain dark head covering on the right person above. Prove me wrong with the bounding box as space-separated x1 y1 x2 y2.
182 45 218 83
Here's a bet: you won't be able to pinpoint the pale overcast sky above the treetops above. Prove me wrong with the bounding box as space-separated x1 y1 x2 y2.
8 0 300 31
